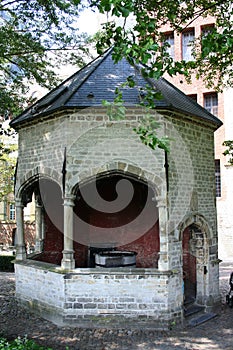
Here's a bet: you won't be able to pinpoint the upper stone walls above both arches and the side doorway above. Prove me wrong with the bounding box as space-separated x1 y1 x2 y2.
17 108 216 236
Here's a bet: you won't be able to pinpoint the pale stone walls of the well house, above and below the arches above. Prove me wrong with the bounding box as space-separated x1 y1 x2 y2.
16 108 219 324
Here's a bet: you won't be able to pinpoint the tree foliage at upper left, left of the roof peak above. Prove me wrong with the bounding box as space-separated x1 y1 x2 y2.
0 0 91 114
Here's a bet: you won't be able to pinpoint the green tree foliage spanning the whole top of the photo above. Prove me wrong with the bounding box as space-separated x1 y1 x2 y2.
0 0 233 114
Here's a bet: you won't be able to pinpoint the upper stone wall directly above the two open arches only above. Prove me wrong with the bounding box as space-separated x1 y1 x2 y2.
16 108 165 197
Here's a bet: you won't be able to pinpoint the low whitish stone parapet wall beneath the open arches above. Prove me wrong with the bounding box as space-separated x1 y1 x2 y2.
15 262 183 328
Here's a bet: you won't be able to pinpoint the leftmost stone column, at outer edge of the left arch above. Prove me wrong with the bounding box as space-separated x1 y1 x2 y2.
15 199 27 260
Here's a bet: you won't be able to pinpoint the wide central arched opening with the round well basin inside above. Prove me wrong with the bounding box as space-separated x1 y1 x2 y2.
74 171 160 268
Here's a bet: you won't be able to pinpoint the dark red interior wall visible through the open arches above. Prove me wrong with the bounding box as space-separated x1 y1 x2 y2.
37 176 159 267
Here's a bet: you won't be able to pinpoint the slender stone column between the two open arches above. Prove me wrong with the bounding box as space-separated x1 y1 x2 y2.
61 195 75 270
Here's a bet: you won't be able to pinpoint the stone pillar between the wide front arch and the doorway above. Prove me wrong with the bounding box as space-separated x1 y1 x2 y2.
157 197 170 271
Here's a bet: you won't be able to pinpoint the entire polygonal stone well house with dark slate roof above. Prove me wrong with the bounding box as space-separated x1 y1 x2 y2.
11 50 221 327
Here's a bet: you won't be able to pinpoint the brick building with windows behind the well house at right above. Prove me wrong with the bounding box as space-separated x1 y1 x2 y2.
158 16 233 261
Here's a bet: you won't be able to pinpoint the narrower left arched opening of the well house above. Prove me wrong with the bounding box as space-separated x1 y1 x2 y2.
18 178 63 264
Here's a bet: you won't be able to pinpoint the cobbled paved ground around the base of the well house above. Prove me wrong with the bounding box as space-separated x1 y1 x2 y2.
0 263 233 350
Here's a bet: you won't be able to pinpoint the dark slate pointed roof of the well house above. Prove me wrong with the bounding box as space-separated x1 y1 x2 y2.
11 49 222 129
